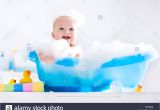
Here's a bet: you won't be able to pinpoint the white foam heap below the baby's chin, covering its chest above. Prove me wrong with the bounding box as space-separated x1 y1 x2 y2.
35 39 82 59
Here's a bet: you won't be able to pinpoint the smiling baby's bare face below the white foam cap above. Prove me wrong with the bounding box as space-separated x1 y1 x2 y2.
52 16 76 46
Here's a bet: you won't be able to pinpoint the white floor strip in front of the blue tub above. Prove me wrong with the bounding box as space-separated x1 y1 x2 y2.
0 92 160 103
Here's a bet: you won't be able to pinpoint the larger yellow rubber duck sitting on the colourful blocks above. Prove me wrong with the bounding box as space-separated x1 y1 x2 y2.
19 70 32 84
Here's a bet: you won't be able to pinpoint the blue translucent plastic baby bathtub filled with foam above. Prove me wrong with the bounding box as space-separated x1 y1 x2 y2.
29 51 151 92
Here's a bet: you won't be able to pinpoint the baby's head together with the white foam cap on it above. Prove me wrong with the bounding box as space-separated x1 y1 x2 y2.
52 10 85 46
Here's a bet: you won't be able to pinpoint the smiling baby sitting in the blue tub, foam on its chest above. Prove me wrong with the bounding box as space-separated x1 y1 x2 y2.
38 10 81 64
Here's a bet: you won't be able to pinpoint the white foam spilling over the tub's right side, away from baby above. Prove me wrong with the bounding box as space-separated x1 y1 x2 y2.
79 41 158 69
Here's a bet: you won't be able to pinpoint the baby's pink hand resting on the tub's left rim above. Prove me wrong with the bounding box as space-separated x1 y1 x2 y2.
38 52 55 64
